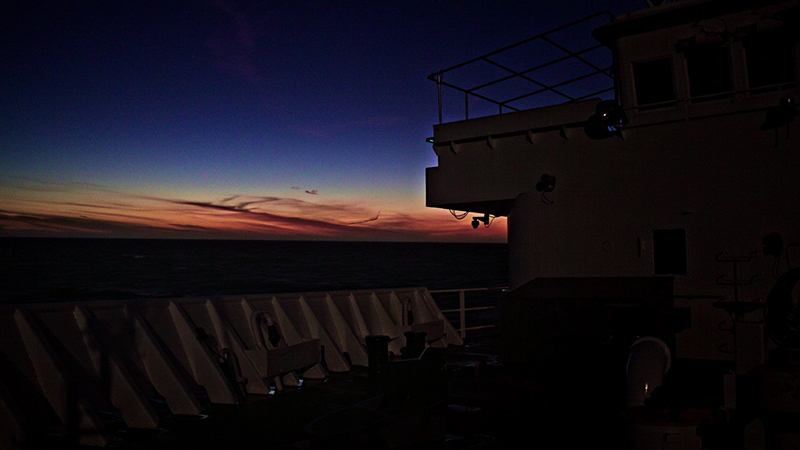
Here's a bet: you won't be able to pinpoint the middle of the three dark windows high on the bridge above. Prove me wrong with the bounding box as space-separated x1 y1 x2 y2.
684 44 733 101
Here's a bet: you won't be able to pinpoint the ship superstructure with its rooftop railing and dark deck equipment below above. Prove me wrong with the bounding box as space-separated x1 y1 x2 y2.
426 0 800 449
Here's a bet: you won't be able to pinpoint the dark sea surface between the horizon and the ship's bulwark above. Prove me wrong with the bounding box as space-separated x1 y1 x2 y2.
0 238 508 303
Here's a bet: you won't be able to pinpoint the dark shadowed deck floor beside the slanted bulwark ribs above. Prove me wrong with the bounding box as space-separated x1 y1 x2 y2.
83 336 621 450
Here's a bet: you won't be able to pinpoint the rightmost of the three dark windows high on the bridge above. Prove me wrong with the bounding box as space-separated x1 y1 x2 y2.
744 34 794 89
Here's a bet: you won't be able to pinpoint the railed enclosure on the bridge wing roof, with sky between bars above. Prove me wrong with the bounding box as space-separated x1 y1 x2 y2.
428 11 616 123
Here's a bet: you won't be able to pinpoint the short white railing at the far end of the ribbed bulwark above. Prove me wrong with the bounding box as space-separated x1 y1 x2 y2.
428 286 508 339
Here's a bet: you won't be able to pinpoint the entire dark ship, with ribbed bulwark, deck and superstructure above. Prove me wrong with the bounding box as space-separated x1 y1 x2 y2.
0 0 800 449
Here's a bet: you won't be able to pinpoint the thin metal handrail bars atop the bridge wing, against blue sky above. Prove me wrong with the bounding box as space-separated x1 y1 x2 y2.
428 10 615 123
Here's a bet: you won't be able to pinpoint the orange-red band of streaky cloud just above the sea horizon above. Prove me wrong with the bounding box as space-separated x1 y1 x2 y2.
0 180 505 241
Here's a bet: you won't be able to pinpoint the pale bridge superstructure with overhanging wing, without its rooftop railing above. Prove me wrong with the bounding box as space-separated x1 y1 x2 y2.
426 0 800 360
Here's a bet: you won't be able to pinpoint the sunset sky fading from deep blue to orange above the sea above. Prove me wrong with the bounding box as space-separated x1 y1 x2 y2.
0 0 645 242
